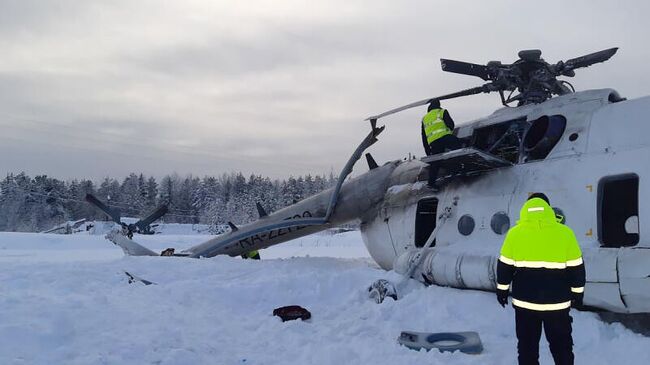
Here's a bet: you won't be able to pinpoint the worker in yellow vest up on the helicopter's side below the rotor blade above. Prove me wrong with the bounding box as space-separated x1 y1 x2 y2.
421 99 461 189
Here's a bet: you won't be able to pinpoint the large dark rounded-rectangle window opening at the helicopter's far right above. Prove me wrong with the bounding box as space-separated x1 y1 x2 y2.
598 174 639 247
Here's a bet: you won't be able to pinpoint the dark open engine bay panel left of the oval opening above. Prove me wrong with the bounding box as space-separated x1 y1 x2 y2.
472 119 529 163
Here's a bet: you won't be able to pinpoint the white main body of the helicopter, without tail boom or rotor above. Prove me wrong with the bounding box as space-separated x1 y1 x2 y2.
361 89 650 312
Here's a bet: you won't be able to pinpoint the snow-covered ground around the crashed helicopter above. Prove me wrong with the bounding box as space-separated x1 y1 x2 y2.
0 232 650 365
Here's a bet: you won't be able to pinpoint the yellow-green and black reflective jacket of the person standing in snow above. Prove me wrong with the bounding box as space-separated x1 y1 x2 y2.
497 198 585 311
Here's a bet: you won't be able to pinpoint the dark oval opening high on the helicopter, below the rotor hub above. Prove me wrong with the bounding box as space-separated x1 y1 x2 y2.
523 115 564 161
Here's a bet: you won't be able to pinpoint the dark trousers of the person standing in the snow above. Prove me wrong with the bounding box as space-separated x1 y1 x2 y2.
515 307 573 365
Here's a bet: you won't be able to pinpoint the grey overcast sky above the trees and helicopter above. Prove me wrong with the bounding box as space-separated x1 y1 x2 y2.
0 0 650 179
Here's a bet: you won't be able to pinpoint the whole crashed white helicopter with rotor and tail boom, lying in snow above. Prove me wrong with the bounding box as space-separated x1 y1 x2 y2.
87 48 650 313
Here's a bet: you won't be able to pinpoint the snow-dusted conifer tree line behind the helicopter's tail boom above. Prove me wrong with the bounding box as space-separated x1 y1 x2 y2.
0 172 336 232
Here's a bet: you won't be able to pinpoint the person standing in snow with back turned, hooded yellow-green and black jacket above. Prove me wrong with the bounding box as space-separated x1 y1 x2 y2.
497 193 585 365
